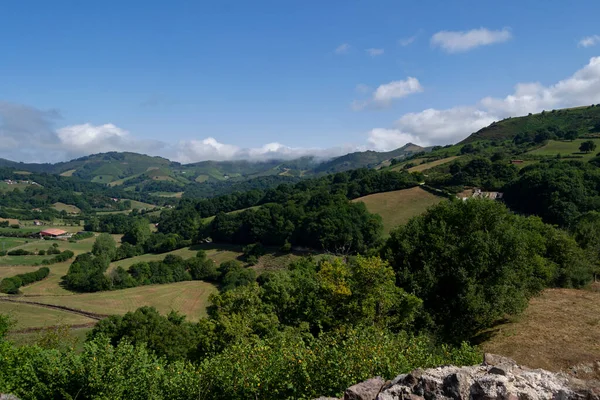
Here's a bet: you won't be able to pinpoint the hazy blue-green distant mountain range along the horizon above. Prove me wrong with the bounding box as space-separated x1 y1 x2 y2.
0 143 428 192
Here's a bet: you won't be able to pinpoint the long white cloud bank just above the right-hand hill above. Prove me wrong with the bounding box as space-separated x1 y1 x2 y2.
368 57 600 150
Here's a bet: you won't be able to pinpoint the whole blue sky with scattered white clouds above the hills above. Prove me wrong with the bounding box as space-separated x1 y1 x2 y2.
0 0 600 162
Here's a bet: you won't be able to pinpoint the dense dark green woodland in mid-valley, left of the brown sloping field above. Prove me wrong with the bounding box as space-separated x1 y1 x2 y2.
158 169 418 253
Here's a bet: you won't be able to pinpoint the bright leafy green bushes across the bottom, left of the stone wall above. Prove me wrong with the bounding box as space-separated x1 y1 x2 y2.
0 321 480 400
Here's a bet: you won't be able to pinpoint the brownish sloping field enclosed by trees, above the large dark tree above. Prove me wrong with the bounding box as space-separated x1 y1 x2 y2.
352 187 444 235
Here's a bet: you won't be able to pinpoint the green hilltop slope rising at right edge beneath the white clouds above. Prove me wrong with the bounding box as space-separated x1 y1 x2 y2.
459 104 600 144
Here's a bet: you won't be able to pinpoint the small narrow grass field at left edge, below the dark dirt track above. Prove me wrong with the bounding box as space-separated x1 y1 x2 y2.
0 301 96 330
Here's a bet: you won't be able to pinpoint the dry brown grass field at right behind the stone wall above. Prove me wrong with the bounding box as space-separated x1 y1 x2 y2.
482 289 600 371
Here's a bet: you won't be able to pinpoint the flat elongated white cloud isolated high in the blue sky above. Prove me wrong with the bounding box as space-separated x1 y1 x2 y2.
431 28 512 53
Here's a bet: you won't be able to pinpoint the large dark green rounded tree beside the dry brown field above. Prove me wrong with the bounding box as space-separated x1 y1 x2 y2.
382 199 590 342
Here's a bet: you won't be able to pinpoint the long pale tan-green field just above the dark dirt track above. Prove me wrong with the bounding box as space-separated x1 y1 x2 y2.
20 281 217 321
